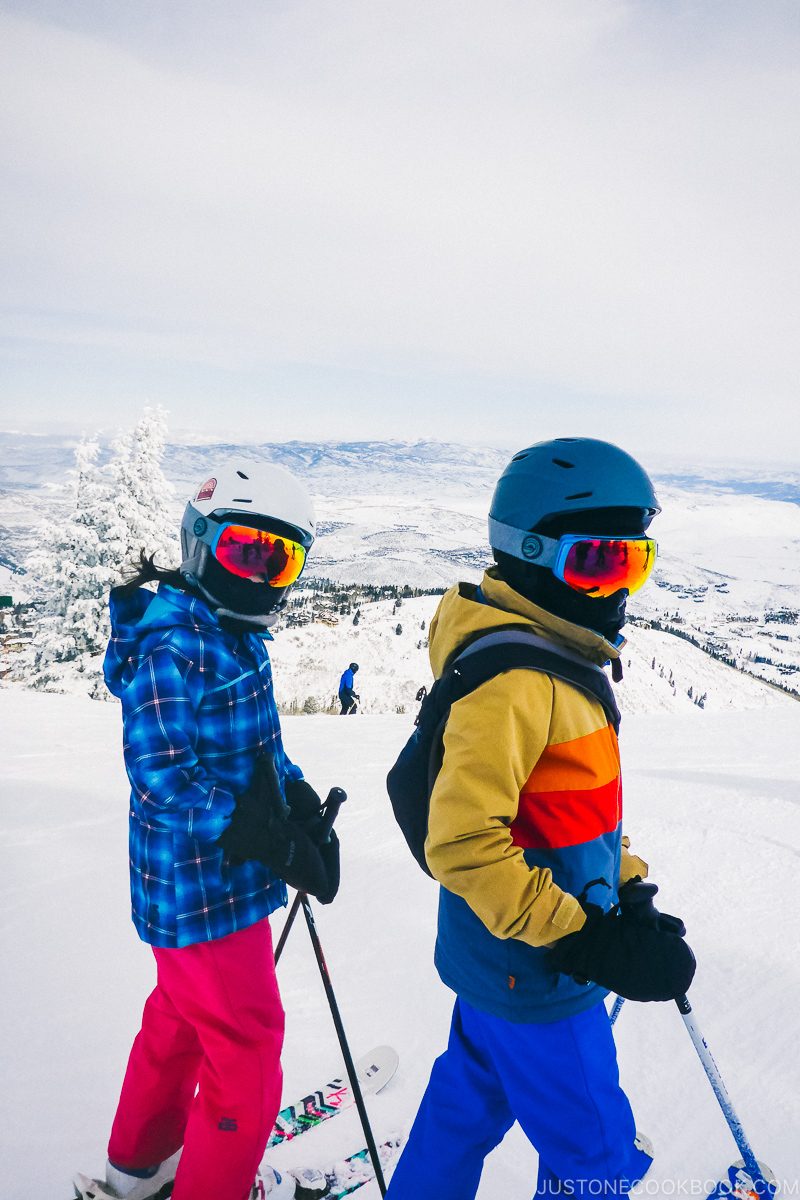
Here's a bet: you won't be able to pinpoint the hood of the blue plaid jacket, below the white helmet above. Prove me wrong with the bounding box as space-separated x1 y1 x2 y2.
103 583 225 696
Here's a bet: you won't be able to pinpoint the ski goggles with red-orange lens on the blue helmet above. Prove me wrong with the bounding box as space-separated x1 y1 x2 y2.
489 520 656 599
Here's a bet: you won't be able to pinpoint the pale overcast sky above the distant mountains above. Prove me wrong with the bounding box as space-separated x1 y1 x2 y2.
0 0 800 463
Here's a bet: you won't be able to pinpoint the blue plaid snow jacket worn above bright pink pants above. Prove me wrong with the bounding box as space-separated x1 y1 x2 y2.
103 583 297 947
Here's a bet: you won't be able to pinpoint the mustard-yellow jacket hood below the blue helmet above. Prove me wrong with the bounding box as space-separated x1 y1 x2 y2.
429 568 625 679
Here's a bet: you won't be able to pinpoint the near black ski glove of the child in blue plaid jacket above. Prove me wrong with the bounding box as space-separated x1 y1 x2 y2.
218 756 339 904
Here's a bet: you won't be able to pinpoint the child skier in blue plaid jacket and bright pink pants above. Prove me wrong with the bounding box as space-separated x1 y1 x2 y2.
81 462 338 1200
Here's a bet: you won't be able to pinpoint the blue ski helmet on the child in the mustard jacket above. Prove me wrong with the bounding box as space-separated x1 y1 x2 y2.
489 438 661 562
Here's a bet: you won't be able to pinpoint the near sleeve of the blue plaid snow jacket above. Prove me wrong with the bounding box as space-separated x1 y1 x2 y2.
122 646 237 841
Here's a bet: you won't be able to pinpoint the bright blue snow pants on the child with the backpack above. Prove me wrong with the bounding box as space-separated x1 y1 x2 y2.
386 998 651 1200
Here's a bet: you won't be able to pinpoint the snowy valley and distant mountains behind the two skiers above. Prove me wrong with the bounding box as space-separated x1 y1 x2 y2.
0 433 800 710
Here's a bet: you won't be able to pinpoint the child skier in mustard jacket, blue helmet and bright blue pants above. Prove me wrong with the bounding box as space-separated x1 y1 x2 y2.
389 438 694 1200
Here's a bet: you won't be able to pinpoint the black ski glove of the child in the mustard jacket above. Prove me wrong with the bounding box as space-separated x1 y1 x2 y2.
549 880 697 1001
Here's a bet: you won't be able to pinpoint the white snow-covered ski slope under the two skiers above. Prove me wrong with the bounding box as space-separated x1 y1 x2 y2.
0 691 800 1200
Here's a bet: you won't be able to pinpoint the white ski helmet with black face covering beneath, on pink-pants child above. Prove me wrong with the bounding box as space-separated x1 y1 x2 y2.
180 458 317 626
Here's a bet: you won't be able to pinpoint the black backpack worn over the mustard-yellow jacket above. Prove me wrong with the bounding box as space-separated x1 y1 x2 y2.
386 629 620 875
